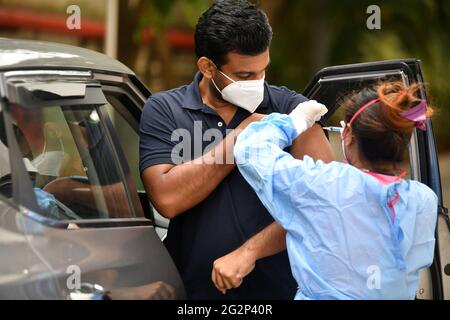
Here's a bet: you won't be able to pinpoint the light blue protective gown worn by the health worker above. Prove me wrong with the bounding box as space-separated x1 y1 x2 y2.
234 113 438 300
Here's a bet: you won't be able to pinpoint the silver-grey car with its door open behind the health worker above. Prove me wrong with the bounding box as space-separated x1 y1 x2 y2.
0 39 450 299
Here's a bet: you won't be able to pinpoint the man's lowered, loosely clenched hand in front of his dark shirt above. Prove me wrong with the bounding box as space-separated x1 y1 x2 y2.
211 246 256 294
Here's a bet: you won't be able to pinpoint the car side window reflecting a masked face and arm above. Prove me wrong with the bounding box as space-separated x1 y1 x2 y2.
11 105 134 220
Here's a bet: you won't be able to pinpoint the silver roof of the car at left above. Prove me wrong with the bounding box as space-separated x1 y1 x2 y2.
0 38 134 75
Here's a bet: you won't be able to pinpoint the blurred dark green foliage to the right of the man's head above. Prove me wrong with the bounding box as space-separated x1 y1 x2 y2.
261 0 450 151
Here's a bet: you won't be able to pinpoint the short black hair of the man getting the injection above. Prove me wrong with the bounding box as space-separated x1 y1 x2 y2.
195 0 272 67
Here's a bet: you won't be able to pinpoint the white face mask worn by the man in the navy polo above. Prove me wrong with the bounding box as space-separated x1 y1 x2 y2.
211 63 265 113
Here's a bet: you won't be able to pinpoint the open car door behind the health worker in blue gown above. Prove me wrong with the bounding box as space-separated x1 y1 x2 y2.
303 59 450 300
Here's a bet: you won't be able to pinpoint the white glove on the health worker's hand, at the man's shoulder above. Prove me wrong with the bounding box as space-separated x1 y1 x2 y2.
289 100 328 135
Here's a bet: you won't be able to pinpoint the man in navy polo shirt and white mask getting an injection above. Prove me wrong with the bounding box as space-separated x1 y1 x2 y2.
140 0 332 299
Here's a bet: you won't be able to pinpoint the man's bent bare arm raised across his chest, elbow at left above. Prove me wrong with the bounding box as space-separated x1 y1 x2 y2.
142 114 264 218
